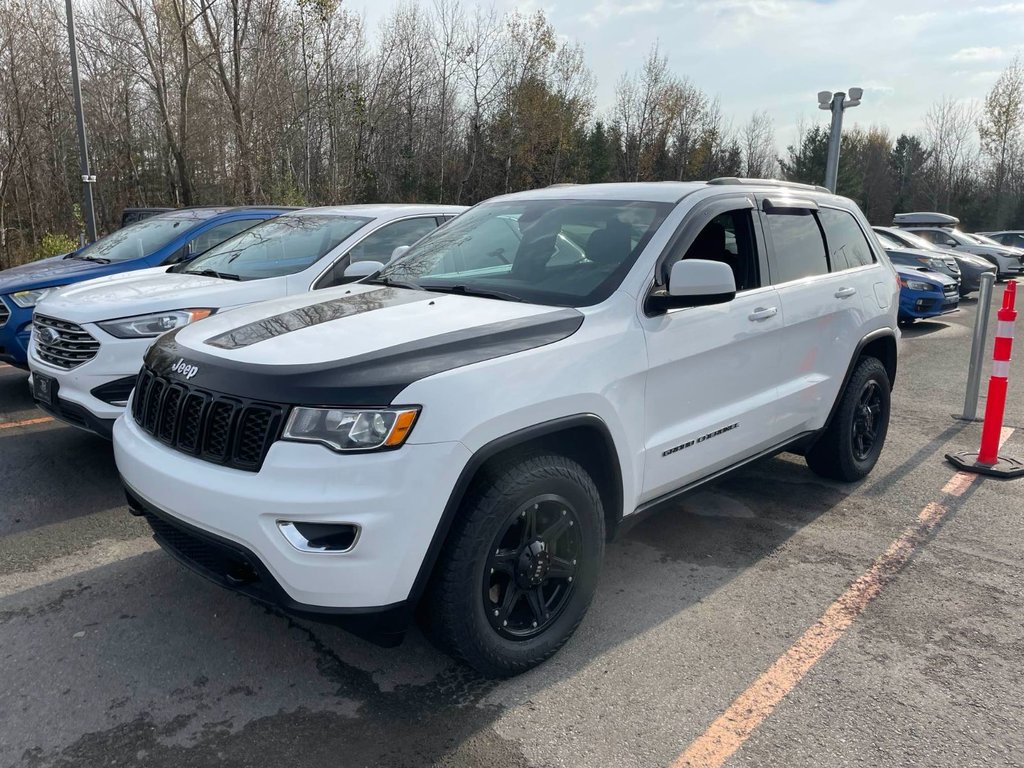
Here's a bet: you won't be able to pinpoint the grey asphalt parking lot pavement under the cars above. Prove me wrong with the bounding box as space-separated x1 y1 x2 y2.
0 287 1024 768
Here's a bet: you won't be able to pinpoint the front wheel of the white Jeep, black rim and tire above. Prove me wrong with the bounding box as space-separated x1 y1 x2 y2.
428 454 604 677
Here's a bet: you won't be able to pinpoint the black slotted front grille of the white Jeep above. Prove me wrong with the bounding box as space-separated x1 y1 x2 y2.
132 369 285 472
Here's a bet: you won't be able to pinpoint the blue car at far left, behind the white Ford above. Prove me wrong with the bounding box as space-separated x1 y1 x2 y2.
0 208 292 368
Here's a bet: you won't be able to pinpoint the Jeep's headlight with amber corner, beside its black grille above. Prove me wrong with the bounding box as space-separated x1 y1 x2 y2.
282 407 420 451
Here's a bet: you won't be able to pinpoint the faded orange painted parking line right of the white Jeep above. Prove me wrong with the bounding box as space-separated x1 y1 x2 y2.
672 428 1014 768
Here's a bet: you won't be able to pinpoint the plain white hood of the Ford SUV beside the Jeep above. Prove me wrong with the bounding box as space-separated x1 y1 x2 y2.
37 266 285 324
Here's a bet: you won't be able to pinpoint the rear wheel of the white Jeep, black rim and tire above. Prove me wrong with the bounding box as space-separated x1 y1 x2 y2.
807 357 892 482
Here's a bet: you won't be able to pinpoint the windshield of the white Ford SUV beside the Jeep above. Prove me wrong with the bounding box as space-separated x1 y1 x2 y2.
181 214 373 280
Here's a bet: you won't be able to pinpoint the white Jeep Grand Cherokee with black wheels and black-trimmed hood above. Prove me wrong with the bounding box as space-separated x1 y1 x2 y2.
114 179 899 676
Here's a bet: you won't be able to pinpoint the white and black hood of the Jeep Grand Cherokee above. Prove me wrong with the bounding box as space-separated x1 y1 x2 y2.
146 284 584 406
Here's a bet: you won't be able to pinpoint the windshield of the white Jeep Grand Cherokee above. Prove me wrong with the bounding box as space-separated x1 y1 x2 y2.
375 199 673 306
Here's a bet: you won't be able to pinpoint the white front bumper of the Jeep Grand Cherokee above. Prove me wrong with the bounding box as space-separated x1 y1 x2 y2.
114 415 470 613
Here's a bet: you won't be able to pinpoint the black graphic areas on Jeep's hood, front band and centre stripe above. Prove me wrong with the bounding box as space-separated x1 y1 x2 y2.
145 288 584 407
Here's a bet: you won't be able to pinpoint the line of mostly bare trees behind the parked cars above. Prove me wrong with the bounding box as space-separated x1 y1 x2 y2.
0 0 1024 266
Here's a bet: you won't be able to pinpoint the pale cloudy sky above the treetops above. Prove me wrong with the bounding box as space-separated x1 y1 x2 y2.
348 0 1024 148
